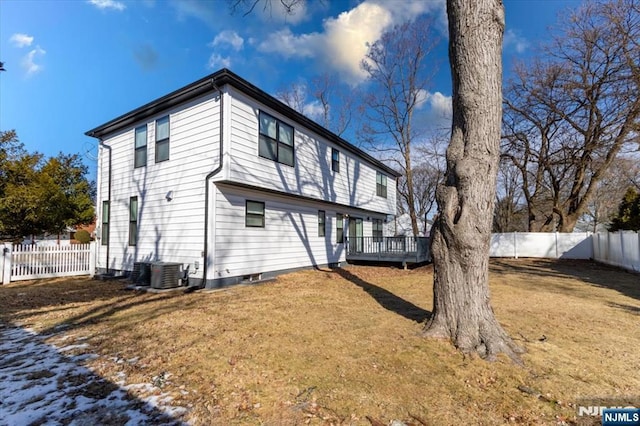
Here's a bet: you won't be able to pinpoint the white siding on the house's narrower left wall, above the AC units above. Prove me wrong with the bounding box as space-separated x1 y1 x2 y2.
97 94 220 277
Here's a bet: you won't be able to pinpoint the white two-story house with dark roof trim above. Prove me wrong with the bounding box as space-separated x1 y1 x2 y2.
86 69 398 288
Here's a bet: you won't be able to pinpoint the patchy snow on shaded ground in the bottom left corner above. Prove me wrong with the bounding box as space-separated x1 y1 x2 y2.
0 324 187 426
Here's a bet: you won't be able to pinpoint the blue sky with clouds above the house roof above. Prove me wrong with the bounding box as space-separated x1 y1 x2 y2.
0 0 580 178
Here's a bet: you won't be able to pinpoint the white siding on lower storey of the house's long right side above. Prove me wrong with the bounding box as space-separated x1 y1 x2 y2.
209 184 360 279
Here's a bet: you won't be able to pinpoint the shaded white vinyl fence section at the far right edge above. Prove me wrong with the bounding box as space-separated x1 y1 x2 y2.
593 231 640 272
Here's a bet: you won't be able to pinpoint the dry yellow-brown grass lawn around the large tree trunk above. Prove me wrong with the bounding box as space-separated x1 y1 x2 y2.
0 260 640 425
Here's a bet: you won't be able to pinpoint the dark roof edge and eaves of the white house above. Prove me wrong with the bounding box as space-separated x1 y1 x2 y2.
85 68 400 177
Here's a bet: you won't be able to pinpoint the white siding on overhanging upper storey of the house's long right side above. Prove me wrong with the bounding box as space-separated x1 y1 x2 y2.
225 88 396 214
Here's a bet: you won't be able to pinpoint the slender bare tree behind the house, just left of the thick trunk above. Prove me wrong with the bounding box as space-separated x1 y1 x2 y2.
361 18 438 235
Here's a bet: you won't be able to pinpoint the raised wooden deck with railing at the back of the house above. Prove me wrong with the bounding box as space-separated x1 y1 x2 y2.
347 237 431 266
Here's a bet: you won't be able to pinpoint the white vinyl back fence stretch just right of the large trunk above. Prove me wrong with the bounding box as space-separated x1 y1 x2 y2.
489 232 593 259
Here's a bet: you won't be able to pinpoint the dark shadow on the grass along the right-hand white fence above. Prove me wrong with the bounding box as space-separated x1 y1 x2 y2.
490 259 640 300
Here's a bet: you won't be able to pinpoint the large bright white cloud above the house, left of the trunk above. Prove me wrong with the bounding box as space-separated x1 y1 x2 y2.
258 2 397 84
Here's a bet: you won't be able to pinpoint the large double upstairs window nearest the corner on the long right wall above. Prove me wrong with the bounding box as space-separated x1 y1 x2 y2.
258 111 294 167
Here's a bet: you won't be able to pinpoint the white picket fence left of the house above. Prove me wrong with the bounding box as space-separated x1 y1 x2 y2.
2 243 95 284
